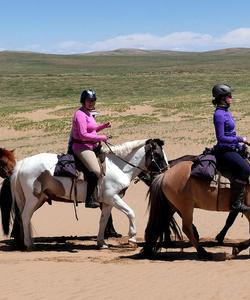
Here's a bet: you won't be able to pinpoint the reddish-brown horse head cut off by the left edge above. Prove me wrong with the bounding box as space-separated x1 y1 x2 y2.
0 148 16 178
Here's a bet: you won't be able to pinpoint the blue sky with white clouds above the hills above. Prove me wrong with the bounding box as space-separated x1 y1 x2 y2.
0 0 250 54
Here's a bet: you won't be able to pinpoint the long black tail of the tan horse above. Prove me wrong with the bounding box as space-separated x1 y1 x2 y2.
142 173 182 257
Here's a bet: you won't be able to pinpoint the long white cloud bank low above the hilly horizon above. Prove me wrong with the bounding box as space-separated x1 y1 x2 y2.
0 28 250 54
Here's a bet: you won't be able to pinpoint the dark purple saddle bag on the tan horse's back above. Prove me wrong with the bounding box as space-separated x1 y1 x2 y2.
191 153 216 181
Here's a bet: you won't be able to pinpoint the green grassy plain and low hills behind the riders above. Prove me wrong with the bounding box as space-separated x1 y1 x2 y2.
0 49 250 155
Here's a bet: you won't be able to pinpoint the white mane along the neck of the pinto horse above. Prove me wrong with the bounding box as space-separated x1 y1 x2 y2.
103 140 146 158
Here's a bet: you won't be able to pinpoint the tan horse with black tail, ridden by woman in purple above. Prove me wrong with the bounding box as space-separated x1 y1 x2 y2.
143 161 250 259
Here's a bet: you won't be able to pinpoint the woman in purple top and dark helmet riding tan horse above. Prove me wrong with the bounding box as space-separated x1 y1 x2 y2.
212 84 250 212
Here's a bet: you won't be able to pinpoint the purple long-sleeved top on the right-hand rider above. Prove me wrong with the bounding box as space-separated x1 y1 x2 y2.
214 107 243 149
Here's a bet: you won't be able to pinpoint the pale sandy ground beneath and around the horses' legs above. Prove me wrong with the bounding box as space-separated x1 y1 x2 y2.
0 106 250 300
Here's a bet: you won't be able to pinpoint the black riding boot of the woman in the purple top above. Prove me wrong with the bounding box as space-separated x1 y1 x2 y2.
231 181 250 213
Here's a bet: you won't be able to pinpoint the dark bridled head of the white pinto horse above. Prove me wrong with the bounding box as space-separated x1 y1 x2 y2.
145 139 168 179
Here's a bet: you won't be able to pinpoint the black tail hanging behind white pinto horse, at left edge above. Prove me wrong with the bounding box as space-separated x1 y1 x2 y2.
0 177 13 235
